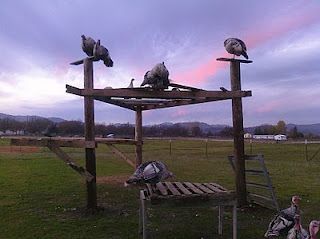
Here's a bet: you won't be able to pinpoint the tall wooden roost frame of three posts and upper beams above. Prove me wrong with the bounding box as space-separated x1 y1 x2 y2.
66 58 252 209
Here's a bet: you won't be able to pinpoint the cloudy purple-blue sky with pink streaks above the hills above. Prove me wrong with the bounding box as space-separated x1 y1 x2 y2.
0 0 320 126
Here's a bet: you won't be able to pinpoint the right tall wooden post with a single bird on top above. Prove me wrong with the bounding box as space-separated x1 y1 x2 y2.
230 60 247 207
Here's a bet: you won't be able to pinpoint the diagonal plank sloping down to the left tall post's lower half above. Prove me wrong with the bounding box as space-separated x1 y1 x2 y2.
48 143 94 182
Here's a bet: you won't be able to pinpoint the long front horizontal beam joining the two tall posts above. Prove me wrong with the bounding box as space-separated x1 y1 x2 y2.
66 85 252 99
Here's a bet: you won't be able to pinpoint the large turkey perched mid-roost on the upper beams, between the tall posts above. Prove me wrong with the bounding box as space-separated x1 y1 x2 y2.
141 62 170 89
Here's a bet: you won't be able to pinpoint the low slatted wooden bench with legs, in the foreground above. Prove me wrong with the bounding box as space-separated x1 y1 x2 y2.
139 182 237 239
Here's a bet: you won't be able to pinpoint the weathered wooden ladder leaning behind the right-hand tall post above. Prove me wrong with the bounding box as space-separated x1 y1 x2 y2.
228 154 279 211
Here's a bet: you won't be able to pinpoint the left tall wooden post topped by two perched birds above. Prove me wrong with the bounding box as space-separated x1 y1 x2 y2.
83 58 97 211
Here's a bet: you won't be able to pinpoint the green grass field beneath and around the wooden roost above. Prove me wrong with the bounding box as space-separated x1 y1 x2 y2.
0 139 320 239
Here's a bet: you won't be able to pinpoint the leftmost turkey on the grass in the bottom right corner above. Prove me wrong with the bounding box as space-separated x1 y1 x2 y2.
264 196 301 238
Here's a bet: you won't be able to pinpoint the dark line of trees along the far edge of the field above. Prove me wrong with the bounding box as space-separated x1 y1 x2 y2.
0 118 315 139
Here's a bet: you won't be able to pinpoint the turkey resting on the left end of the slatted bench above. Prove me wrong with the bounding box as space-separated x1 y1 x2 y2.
126 161 173 184
